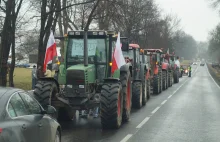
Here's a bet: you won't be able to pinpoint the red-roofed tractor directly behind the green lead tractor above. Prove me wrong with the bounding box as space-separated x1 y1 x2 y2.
119 42 150 109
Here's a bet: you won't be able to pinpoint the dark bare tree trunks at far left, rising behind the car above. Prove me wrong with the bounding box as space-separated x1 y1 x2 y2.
0 0 23 86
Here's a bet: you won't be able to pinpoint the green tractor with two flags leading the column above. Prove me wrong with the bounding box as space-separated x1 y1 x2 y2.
34 31 131 129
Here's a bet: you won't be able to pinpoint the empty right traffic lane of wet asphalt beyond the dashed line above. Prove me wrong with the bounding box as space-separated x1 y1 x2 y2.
128 67 220 142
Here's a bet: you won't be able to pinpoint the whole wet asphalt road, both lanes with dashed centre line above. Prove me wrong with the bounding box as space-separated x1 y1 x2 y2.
62 66 220 142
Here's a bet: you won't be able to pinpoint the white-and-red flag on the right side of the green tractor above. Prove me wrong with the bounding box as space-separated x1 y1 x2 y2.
111 33 126 73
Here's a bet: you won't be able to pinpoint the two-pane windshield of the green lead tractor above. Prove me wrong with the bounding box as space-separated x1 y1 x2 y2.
67 39 106 63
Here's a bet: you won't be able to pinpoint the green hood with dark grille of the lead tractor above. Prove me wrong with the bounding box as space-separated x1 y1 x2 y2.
66 64 95 85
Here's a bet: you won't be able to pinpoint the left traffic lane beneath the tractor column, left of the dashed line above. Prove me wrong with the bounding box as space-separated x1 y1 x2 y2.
61 67 198 142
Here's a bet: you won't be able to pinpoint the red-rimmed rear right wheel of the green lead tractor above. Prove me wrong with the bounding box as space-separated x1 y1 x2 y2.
120 72 132 122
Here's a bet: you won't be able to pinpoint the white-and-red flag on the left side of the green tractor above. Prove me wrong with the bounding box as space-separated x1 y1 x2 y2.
43 31 57 72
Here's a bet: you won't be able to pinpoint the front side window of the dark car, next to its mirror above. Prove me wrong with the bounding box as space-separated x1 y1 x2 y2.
19 93 41 114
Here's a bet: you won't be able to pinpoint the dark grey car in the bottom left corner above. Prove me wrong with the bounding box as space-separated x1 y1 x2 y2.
0 87 61 142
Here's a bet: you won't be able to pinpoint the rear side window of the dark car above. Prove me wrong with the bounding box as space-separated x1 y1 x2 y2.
10 94 30 116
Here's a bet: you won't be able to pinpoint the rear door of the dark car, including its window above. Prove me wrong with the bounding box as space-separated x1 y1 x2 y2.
9 93 39 142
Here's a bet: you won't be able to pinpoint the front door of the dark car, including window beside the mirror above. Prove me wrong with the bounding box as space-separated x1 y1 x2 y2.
19 92 51 142
